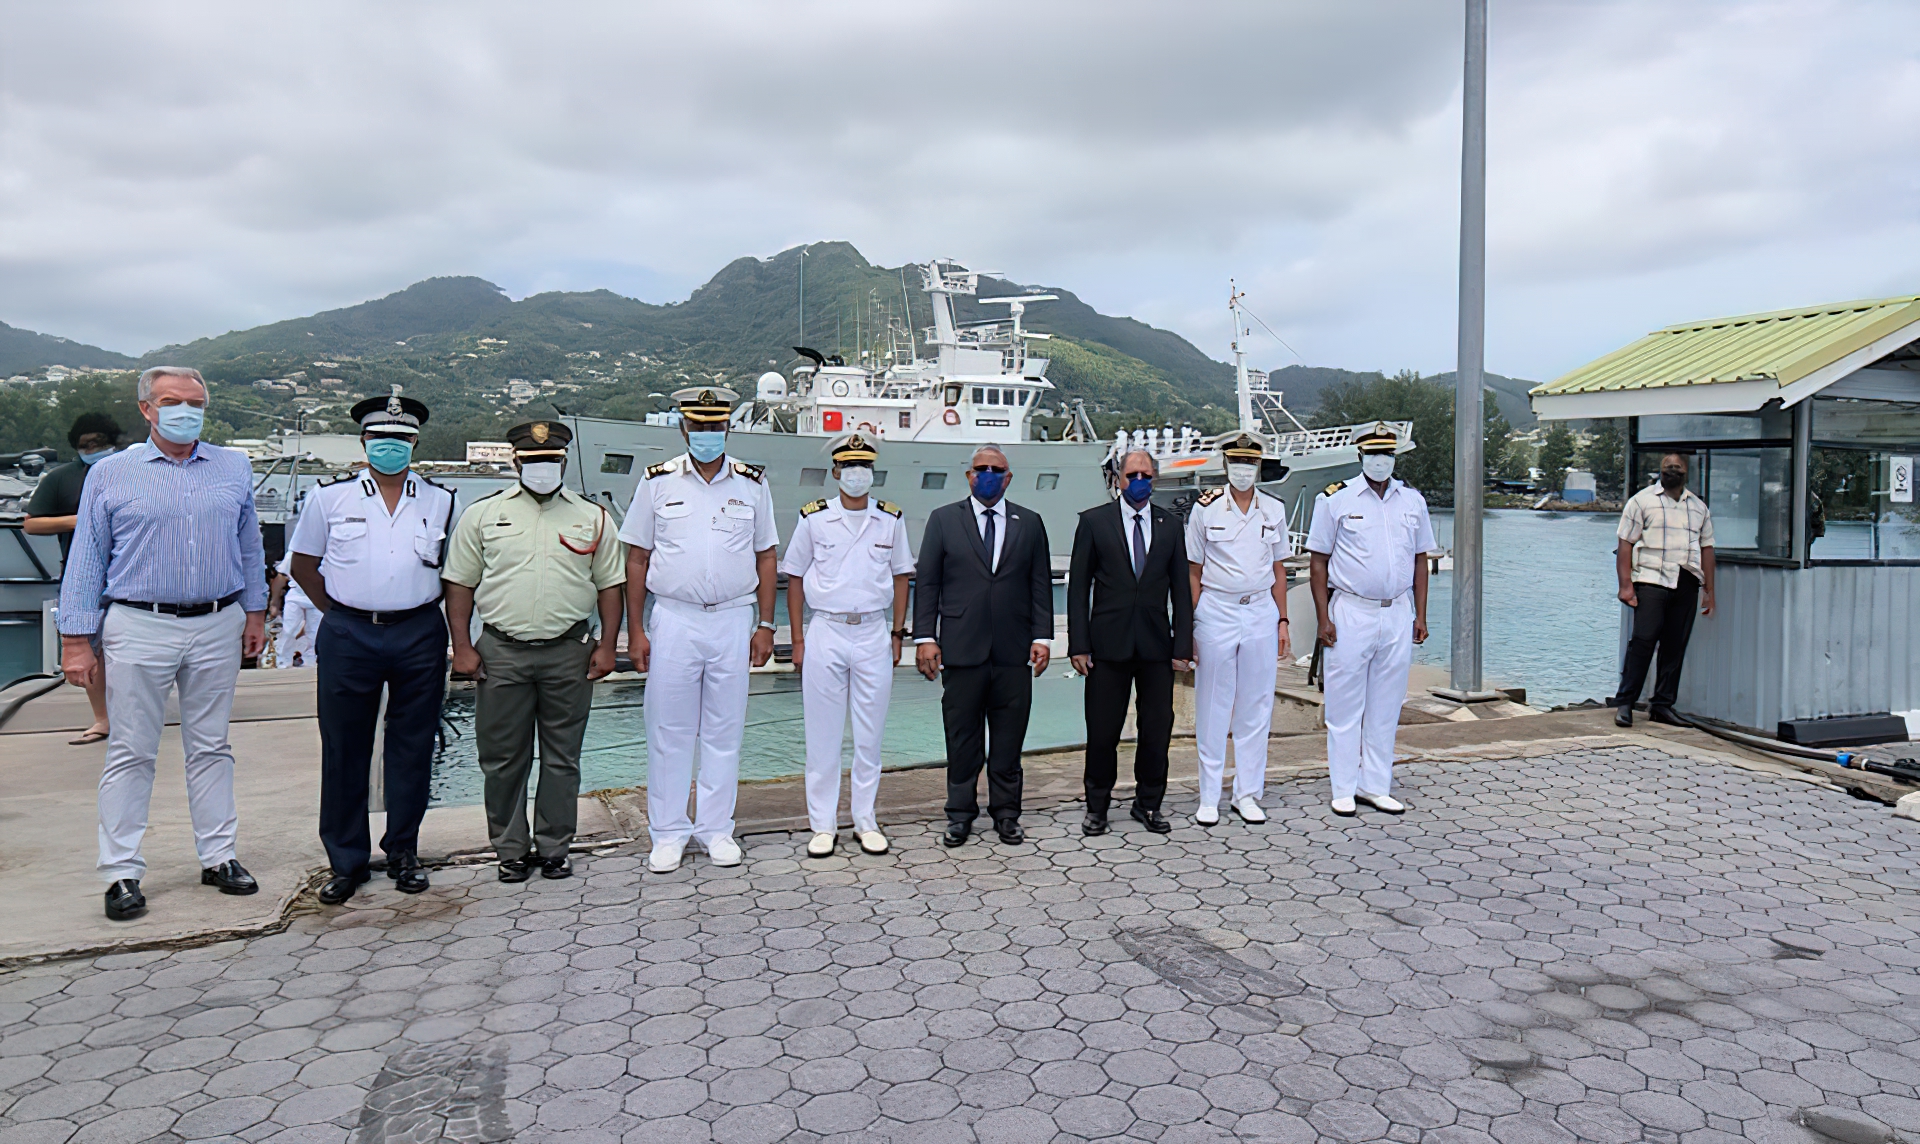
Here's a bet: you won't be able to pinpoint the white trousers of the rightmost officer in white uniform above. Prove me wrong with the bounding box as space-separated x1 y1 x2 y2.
1321 591 1413 798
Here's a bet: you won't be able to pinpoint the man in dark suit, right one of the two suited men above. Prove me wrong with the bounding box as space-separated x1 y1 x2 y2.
1068 451 1194 837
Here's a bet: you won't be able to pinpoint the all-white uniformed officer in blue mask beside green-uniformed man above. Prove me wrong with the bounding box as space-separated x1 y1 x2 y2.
620 386 780 873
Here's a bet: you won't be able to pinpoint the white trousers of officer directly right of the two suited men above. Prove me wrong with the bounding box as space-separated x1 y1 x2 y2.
1194 591 1281 806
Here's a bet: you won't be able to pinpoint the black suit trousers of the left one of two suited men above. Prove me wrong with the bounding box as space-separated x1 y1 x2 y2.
941 664 1033 827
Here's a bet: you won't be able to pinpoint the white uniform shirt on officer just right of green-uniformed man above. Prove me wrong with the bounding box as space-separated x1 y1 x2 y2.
620 453 780 605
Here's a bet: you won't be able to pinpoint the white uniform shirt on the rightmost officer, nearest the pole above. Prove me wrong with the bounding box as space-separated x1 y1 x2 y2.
1308 476 1434 599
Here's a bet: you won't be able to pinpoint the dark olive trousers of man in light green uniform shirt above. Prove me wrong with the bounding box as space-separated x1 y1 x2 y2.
474 620 595 858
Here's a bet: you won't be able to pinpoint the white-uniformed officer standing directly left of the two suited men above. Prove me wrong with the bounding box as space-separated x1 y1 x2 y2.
780 434 914 858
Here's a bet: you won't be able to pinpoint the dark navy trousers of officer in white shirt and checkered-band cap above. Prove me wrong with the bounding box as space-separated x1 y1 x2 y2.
313 608 447 873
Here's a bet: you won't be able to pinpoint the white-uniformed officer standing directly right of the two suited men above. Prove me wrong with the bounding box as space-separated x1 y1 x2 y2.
1187 432 1292 825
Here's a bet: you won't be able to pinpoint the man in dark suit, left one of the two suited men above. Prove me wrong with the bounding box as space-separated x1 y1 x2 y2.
914 445 1054 846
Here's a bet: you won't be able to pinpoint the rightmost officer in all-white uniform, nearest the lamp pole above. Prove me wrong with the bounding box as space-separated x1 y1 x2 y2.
1308 422 1434 816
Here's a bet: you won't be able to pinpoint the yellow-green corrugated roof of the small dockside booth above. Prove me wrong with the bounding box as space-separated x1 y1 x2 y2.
1532 294 1920 397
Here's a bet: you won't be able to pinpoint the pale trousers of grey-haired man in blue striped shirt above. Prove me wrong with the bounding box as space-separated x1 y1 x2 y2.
96 605 246 883
